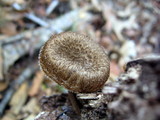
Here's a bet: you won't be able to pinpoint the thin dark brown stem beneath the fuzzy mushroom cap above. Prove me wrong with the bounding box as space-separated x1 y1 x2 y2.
68 91 81 115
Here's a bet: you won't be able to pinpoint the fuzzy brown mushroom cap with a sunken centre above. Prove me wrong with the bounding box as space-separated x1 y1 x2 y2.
39 32 110 93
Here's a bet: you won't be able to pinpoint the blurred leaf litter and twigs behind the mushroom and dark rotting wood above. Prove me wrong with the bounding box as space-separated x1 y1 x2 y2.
0 0 160 120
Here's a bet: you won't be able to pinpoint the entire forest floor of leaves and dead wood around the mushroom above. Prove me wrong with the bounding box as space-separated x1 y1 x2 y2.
0 0 160 120
